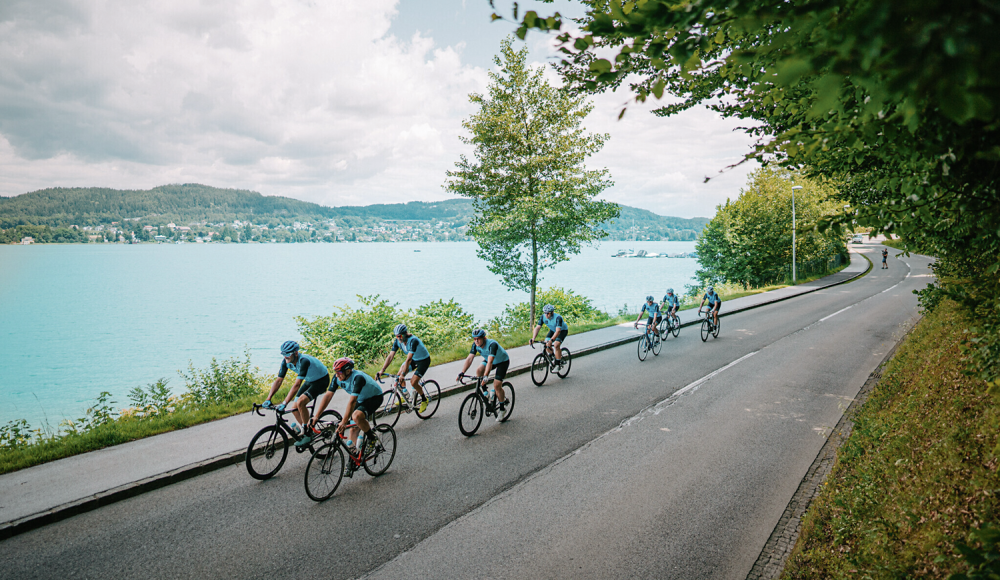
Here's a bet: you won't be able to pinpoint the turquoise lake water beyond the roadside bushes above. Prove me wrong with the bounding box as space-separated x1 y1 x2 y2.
0 242 697 426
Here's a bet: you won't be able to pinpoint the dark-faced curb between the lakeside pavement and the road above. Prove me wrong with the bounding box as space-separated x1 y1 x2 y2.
0 252 872 541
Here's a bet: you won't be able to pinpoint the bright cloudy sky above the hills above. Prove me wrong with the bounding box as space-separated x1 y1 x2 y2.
0 0 755 217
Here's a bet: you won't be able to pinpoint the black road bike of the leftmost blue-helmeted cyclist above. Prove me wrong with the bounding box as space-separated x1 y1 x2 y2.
246 401 341 481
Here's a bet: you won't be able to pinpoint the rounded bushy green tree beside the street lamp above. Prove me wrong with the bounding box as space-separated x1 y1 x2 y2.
696 168 846 287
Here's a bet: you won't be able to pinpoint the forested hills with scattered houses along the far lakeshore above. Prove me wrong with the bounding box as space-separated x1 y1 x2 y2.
0 184 709 240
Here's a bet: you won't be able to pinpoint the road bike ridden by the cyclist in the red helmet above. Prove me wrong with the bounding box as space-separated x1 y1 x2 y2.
305 416 396 501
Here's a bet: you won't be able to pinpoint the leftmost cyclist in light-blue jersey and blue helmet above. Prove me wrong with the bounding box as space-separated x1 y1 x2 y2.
262 340 336 447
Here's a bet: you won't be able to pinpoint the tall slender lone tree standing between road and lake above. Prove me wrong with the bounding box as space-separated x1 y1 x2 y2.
445 38 619 326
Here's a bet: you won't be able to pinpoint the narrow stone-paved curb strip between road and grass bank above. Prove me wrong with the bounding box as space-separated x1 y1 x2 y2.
746 318 920 580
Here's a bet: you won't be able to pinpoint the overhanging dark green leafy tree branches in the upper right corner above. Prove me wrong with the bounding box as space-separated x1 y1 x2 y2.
515 0 1000 381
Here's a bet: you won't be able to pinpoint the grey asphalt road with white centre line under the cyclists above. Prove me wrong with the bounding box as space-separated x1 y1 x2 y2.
0 247 930 579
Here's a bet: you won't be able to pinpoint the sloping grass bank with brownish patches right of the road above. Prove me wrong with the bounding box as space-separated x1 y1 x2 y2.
782 302 1000 580
